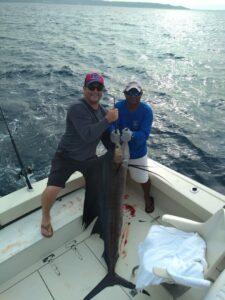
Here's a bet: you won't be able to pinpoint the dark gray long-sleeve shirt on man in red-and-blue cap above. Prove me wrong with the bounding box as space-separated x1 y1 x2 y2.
57 99 109 161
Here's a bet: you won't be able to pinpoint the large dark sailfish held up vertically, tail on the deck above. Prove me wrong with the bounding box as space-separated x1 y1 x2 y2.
83 145 142 300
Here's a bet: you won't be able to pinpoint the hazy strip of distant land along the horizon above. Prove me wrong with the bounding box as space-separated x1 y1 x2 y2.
0 0 189 10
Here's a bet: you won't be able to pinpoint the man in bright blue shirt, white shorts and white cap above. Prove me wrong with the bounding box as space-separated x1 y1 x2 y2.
111 81 154 213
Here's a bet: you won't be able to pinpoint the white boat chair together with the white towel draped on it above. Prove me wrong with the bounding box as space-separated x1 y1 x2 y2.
136 208 225 288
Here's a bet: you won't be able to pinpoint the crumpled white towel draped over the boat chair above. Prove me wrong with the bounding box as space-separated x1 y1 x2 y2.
136 225 211 289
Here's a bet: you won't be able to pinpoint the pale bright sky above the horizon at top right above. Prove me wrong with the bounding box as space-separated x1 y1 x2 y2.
110 0 225 9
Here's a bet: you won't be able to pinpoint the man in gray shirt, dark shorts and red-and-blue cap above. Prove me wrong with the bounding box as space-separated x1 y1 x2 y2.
41 73 118 238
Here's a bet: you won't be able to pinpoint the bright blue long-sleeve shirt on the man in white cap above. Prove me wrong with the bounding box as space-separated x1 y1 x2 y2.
114 100 153 159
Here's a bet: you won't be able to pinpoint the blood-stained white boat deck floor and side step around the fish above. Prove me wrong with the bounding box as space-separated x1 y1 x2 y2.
0 179 211 300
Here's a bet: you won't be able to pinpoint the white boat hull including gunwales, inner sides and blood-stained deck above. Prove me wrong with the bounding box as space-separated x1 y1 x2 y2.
0 159 225 300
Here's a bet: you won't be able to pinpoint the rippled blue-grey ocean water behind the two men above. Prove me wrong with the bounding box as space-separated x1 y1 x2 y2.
0 3 225 196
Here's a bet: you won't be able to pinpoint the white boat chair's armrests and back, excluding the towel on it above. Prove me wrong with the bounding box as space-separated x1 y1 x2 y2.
153 208 225 283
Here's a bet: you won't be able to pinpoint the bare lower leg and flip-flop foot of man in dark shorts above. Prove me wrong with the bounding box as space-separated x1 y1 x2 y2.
41 186 62 237
